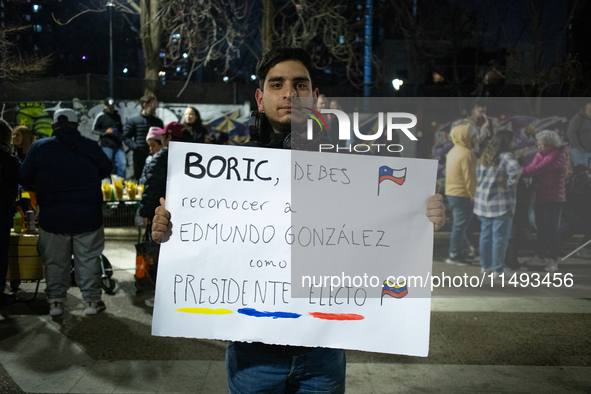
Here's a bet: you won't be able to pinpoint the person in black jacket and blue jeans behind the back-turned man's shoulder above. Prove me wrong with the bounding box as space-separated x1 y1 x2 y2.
92 97 127 178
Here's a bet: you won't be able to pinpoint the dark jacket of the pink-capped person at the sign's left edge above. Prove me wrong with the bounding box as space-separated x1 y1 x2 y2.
140 147 168 219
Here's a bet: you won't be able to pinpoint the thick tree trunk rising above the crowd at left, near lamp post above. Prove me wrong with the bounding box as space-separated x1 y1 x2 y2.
140 0 162 94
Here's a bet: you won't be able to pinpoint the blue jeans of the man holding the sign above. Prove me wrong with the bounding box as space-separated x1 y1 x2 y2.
226 342 346 394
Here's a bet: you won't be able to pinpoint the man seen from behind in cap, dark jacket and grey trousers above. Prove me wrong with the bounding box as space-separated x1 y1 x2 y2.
20 109 111 316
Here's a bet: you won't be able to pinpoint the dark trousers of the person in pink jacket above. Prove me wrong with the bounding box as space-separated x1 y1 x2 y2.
534 202 564 260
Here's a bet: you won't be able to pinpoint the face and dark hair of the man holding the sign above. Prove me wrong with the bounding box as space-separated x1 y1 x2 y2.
255 60 318 132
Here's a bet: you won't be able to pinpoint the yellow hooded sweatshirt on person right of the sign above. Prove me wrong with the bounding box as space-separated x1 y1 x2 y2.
445 121 477 200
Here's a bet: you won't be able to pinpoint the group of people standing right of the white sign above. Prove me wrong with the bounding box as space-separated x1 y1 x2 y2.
445 102 591 278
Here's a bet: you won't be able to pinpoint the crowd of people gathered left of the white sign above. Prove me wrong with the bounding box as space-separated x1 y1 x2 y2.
0 95 220 310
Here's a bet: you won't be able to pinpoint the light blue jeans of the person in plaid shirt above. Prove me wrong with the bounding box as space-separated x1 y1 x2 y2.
478 211 513 272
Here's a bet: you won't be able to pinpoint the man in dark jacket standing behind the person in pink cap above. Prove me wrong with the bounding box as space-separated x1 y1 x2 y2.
123 95 164 179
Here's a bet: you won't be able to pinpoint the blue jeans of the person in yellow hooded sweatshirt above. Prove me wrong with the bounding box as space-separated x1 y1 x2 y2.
447 196 474 261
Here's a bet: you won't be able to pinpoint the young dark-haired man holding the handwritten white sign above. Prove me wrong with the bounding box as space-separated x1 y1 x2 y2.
152 48 445 393
